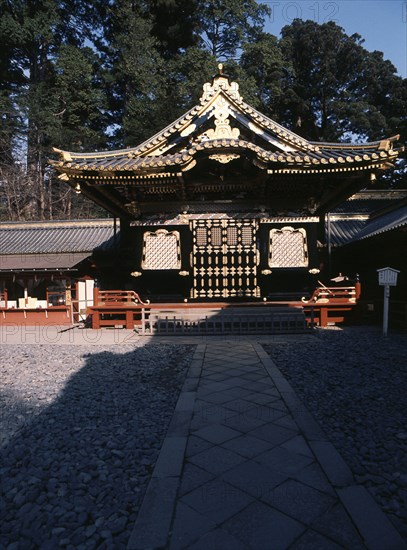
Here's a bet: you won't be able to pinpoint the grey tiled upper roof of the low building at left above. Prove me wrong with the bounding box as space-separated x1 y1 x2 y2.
0 220 114 255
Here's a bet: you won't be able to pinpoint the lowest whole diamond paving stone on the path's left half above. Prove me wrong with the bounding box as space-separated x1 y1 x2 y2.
181 479 253 525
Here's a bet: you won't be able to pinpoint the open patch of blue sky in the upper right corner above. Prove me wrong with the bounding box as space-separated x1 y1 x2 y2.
261 0 407 78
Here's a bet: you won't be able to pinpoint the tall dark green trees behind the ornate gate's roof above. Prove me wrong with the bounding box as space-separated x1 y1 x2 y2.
0 0 407 219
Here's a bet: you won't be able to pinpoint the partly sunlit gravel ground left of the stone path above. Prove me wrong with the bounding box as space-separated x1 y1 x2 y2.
0 344 193 550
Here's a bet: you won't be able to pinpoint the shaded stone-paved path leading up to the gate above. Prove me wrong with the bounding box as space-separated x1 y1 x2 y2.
128 340 405 550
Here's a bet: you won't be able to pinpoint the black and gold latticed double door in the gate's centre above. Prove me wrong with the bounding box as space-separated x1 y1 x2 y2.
191 219 260 298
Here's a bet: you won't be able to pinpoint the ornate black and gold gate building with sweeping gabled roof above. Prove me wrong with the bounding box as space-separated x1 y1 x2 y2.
51 68 402 301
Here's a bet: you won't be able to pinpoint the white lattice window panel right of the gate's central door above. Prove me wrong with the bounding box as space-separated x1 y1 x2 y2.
269 227 308 267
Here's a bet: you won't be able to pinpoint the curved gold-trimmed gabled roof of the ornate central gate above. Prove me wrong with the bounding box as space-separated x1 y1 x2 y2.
51 64 402 218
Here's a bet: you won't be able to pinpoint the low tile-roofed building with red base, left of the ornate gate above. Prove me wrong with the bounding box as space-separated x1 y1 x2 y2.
0 220 117 325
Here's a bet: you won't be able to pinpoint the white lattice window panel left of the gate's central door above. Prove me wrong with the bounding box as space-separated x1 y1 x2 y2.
141 229 181 269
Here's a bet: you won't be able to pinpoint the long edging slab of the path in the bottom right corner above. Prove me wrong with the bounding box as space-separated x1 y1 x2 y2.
338 485 407 550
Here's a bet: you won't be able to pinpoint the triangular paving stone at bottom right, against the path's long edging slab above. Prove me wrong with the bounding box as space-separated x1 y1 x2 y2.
312 502 366 550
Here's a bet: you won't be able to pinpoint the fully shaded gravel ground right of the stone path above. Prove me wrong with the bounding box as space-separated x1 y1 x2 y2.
264 327 407 540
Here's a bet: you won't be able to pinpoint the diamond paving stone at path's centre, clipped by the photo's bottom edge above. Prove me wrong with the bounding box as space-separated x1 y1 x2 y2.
222 502 305 550
